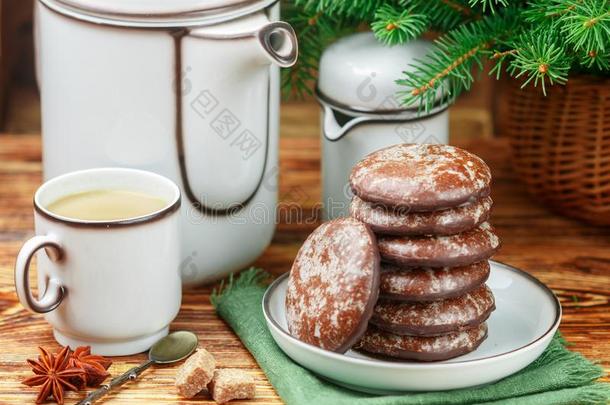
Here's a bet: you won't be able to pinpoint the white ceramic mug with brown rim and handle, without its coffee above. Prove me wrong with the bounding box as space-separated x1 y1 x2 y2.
15 168 182 356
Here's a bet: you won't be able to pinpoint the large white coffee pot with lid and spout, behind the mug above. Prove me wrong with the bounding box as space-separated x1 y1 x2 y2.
35 0 298 285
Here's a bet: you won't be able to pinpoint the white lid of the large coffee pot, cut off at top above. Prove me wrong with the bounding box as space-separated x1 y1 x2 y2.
40 0 278 27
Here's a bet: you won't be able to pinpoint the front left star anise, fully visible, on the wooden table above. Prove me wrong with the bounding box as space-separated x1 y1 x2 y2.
23 347 85 404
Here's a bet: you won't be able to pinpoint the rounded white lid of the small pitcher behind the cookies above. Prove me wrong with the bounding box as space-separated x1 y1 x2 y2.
317 32 440 113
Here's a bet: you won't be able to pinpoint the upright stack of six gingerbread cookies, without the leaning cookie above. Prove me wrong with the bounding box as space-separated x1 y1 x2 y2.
350 144 499 361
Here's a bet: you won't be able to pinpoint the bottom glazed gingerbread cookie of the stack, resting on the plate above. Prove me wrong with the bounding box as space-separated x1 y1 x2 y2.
354 323 487 361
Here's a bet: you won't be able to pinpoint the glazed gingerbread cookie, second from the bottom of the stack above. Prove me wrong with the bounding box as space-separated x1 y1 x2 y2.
370 285 496 336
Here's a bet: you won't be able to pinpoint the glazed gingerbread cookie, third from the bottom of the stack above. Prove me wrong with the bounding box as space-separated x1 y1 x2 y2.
379 260 490 302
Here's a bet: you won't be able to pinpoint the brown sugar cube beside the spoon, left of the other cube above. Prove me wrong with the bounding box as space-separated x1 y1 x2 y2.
176 349 216 398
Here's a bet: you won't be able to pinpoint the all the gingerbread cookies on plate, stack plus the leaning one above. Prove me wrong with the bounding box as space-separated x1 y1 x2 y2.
285 144 499 361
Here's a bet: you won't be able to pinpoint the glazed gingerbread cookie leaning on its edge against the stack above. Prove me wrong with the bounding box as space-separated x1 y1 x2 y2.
286 218 379 353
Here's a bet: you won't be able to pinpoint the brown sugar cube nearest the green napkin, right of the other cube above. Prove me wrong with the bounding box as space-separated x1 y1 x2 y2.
208 368 256 404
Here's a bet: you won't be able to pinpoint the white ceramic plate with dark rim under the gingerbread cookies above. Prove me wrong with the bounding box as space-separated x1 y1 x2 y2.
263 261 561 393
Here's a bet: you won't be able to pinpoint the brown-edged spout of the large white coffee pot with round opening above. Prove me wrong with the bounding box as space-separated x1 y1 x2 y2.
175 12 298 216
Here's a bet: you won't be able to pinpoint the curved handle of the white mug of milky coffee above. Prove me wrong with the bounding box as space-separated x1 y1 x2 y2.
15 235 66 314
